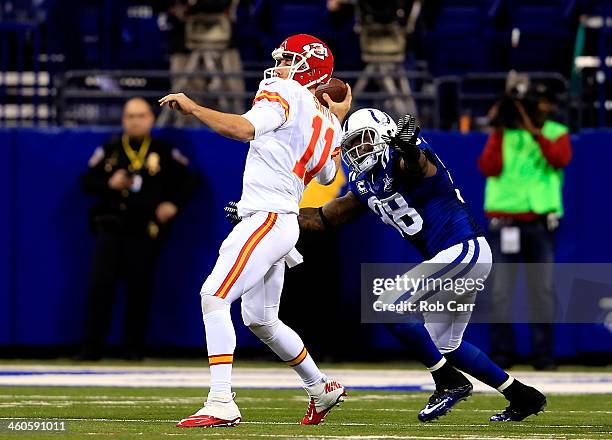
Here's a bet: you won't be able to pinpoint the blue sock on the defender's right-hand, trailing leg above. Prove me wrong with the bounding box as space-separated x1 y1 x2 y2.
444 341 510 389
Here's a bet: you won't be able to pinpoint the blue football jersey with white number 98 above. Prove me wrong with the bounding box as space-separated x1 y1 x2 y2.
349 138 483 259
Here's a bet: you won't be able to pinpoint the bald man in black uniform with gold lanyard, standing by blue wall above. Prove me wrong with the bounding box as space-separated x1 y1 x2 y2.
80 98 194 360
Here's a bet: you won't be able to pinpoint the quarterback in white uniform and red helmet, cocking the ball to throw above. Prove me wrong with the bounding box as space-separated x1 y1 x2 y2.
160 34 351 427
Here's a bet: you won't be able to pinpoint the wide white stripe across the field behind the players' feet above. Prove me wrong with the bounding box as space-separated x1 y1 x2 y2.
0 365 612 394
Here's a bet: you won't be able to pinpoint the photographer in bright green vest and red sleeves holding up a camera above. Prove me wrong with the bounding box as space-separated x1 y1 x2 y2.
478 85 572 370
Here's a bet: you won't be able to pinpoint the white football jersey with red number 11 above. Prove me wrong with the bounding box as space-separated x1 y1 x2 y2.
238 78 342 216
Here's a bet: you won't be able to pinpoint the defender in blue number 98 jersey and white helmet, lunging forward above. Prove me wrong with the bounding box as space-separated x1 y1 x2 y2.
299 109 546 421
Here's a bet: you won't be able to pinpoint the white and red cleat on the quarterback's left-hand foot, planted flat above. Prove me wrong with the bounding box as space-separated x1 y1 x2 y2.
176 392 242 428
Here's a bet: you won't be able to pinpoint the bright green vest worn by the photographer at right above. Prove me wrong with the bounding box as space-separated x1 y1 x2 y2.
484 121 568 216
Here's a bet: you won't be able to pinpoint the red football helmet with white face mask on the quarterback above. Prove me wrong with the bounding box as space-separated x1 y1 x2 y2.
264 34 334 87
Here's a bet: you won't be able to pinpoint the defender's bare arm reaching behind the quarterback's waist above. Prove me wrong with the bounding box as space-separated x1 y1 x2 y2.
298 191 366 231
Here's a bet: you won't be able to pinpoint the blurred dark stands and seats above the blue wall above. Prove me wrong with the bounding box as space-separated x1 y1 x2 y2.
0 0 612 127
